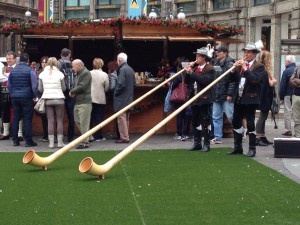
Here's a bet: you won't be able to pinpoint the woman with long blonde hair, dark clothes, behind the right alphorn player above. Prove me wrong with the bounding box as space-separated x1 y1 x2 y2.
256 51 277 146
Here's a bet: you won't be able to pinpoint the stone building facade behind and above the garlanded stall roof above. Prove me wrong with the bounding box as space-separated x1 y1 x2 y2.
0 0 300 77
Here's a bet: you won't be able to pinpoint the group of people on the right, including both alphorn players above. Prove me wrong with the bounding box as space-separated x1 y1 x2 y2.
171 42 300 157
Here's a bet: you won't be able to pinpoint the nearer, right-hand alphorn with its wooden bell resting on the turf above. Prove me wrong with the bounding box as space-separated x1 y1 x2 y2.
79 66 235 179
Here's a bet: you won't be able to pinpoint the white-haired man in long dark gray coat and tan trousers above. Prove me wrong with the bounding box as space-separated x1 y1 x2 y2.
114 53 135 143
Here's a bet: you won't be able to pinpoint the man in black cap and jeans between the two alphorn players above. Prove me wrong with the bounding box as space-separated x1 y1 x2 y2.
210 46 238 144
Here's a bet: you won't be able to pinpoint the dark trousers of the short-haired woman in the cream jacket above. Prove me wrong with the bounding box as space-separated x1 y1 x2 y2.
90 103 105 140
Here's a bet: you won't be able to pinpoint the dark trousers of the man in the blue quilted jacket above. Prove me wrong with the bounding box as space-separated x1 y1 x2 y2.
12 98 33 142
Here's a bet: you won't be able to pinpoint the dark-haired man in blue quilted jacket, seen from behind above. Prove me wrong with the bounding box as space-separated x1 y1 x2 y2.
7 53 38 147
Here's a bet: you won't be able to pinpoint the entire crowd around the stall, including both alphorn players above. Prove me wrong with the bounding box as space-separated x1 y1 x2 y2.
0 43 300 157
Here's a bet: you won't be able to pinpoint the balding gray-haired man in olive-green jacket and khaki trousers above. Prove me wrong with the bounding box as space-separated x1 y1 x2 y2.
69 59 92 149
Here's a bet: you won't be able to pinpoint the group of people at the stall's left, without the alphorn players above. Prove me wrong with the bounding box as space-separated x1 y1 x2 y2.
0 48 135 149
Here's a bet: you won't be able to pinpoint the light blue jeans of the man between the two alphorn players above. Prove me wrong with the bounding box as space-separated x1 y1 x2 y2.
213 101 234 141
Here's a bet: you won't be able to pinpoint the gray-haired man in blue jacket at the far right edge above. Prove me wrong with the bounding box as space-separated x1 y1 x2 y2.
279 55 296 136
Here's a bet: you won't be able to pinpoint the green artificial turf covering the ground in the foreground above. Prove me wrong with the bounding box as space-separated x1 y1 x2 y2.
0 149 300 225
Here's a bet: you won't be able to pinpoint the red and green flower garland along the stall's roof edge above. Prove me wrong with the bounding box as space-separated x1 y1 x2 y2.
0 16 244 38
